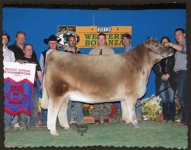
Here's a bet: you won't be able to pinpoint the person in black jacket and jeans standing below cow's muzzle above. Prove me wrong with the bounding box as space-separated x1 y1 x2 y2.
153 37 176 123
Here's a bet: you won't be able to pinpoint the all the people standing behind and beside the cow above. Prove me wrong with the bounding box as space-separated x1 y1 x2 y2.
2 29 188 130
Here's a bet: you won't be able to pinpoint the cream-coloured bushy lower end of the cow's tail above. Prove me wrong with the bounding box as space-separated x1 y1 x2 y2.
41 74 48 109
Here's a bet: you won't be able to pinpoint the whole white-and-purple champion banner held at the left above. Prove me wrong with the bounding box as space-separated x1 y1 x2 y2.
4 62 36 115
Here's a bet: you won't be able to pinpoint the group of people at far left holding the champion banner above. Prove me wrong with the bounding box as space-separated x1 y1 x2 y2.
2 32 42 130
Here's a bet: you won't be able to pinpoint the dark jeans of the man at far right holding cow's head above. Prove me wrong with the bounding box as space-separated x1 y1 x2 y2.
176 70 188 125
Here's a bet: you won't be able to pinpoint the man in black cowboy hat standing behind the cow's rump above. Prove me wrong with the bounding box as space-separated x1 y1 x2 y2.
39 35 61 126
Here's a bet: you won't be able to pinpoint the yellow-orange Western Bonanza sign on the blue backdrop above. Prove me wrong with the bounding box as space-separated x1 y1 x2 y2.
56 26 132 48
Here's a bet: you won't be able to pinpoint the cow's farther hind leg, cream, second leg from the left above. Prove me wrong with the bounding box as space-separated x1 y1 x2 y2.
58 100 70 130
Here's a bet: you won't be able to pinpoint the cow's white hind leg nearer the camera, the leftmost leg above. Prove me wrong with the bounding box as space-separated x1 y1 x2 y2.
47 97 63 136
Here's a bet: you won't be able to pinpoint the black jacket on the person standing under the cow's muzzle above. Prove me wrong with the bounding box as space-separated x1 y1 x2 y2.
153 55 176 94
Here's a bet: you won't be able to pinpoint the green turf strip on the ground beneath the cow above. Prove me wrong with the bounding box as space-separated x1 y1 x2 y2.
4 121 188 148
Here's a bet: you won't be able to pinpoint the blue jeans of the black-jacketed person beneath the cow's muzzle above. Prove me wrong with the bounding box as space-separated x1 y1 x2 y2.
159 80 176 121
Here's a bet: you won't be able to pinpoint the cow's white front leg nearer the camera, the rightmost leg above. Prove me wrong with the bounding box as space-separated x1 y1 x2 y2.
125 98 139 128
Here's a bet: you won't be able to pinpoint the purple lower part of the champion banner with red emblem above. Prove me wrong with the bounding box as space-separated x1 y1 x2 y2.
4 78 34 115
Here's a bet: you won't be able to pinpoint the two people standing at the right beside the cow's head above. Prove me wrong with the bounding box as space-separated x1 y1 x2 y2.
153 28 188 127
